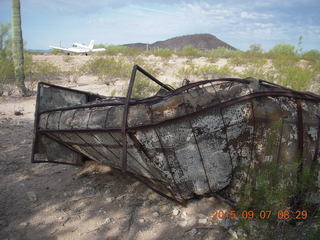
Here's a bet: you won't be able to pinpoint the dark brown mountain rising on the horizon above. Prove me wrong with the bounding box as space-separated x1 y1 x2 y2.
124 34 236 50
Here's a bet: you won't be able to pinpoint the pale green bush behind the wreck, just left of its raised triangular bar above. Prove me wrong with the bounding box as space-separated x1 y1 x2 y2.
81 57 131 83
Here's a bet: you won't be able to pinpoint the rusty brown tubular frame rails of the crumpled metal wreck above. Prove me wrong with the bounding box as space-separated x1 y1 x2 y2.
33 65 320 171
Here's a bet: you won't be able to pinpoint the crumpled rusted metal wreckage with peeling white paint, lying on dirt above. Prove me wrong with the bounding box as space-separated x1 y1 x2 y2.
32 65 320 202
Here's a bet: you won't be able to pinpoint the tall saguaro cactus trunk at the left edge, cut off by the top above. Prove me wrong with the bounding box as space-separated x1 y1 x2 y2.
11 0 26 96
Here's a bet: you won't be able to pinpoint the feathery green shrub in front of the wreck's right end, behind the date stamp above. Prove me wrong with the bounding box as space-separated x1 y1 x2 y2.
235 120 320 239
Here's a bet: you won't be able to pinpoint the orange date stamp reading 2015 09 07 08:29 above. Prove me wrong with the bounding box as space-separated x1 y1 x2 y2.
210 209 308 220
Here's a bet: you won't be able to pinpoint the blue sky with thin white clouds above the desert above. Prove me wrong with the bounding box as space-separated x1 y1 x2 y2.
0 0 320 50
